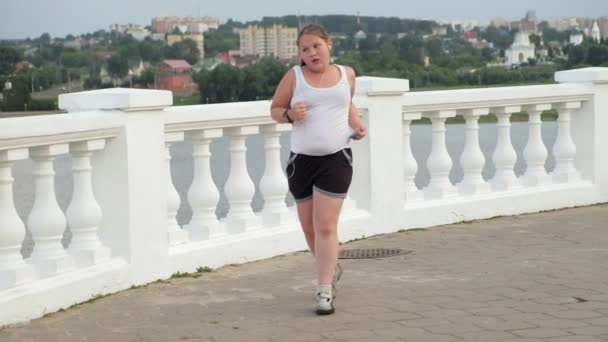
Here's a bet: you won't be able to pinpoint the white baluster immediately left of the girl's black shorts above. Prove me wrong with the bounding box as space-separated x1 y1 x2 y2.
260 124 295 225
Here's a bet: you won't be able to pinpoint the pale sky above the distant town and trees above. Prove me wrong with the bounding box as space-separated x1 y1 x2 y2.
0 0 608 39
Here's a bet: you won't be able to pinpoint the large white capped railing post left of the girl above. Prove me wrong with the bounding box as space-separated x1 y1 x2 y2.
59 88 173 284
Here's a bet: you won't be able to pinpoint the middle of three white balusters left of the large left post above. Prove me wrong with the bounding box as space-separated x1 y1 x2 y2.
27 144 74 277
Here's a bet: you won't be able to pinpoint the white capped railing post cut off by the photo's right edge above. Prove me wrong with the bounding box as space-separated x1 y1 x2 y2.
555 68 608 201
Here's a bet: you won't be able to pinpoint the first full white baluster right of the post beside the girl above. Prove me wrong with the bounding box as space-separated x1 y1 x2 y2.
424 110 456 199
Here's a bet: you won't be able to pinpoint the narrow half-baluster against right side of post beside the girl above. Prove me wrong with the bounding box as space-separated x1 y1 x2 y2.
403 113 422 202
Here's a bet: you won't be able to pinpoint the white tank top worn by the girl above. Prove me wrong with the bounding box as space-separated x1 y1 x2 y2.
291 65 352 156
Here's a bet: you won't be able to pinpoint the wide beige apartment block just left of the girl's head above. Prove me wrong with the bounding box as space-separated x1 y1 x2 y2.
236 25 298 59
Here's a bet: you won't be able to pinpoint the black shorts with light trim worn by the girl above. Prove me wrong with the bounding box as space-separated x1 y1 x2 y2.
285 148 353 202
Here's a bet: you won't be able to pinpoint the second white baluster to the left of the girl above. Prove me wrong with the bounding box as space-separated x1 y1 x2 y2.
222 126 262 233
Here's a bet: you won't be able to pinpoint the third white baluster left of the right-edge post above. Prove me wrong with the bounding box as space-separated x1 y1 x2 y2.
490 106 521 191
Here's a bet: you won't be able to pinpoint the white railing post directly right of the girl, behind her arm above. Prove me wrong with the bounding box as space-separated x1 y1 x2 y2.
353 77 409 233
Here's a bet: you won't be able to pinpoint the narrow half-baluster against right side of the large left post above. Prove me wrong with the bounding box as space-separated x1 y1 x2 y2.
165 132 188 246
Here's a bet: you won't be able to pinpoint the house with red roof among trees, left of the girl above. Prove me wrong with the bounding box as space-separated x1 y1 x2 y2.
155 59 198 93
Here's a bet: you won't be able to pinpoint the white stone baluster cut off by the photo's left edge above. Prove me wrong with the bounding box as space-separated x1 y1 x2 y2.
0 148 34 290
